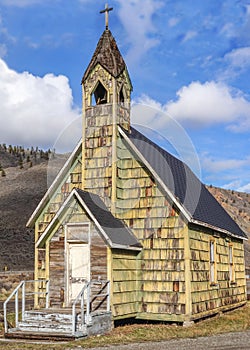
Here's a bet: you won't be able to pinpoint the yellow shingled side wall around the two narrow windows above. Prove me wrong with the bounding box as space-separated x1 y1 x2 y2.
189 228 246 318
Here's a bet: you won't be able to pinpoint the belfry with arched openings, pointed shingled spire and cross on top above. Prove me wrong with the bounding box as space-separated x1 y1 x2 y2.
82 5 132 116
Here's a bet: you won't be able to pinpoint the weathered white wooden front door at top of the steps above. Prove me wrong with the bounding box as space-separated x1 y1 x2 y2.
68 243 90 304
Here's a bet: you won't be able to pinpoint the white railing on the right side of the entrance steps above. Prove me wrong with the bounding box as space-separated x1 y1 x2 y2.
72 280 110 335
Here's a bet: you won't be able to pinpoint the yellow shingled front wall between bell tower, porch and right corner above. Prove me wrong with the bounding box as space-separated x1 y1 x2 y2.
116 136 186 320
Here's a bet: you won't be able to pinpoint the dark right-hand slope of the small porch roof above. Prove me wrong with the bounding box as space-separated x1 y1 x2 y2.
75 189 142 248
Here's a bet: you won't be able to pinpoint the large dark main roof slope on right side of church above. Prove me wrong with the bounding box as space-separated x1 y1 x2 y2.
123 127 247 238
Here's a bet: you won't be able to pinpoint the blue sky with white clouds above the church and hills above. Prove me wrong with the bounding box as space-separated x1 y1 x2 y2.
0 0 250 192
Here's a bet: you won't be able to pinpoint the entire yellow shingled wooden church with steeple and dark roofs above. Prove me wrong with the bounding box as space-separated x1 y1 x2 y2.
4 4 246 340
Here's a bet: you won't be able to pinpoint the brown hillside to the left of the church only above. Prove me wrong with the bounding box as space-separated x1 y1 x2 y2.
0 147 65 270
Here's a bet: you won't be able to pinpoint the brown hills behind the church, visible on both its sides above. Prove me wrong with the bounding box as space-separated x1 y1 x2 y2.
0 145 250 270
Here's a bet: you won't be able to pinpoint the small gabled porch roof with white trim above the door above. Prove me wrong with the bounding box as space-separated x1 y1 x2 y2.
36 188 142 250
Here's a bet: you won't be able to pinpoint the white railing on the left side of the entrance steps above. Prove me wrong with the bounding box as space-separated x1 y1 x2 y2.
3 280 50 333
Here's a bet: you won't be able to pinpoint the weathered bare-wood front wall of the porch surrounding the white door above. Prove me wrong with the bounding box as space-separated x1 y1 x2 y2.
36 203 107 307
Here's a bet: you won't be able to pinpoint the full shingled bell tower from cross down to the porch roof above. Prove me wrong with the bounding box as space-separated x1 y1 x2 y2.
82 5 132 210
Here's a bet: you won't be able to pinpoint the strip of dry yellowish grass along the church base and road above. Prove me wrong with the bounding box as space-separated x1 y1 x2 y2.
0 302 250 350
